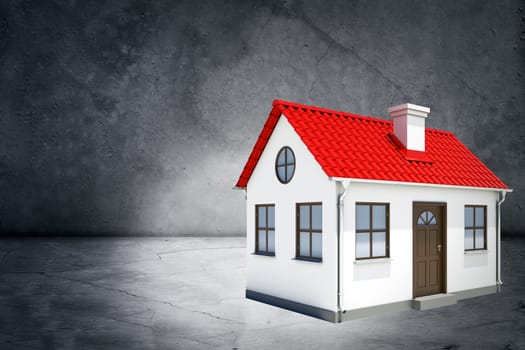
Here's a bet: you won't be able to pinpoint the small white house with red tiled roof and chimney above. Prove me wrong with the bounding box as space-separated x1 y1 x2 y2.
235 100 512 322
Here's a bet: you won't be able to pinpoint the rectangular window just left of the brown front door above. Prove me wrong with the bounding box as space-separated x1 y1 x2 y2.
355 203 389 259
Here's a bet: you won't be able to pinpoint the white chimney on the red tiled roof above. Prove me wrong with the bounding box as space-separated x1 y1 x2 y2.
388 103 430 152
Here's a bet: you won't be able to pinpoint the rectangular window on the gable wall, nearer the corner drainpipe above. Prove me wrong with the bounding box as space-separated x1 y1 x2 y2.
296 203 323 261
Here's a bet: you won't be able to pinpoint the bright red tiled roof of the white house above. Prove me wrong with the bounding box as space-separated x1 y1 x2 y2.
236 100 508 189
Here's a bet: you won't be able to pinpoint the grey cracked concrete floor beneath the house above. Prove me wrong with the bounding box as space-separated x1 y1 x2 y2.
0 237 525 350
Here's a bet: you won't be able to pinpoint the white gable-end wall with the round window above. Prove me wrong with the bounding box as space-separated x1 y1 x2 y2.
246 116 337 310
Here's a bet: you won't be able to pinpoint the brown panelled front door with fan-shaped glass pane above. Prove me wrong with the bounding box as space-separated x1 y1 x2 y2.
413 203 446 298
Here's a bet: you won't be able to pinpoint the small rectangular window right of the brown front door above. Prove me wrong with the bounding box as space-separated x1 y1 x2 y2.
465 205 487 250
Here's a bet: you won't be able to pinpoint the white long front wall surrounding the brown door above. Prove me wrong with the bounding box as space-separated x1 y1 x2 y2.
342 182 497 310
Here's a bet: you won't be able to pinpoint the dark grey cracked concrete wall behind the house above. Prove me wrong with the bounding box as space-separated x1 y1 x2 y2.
0 0 525 235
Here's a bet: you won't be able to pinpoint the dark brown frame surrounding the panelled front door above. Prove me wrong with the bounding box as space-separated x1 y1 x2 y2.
412 201 448 298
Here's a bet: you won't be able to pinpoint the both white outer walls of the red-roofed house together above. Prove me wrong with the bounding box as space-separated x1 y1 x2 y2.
246 116 497 310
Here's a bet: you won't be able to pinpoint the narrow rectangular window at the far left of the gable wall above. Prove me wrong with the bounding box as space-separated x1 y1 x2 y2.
255 204 275 255
